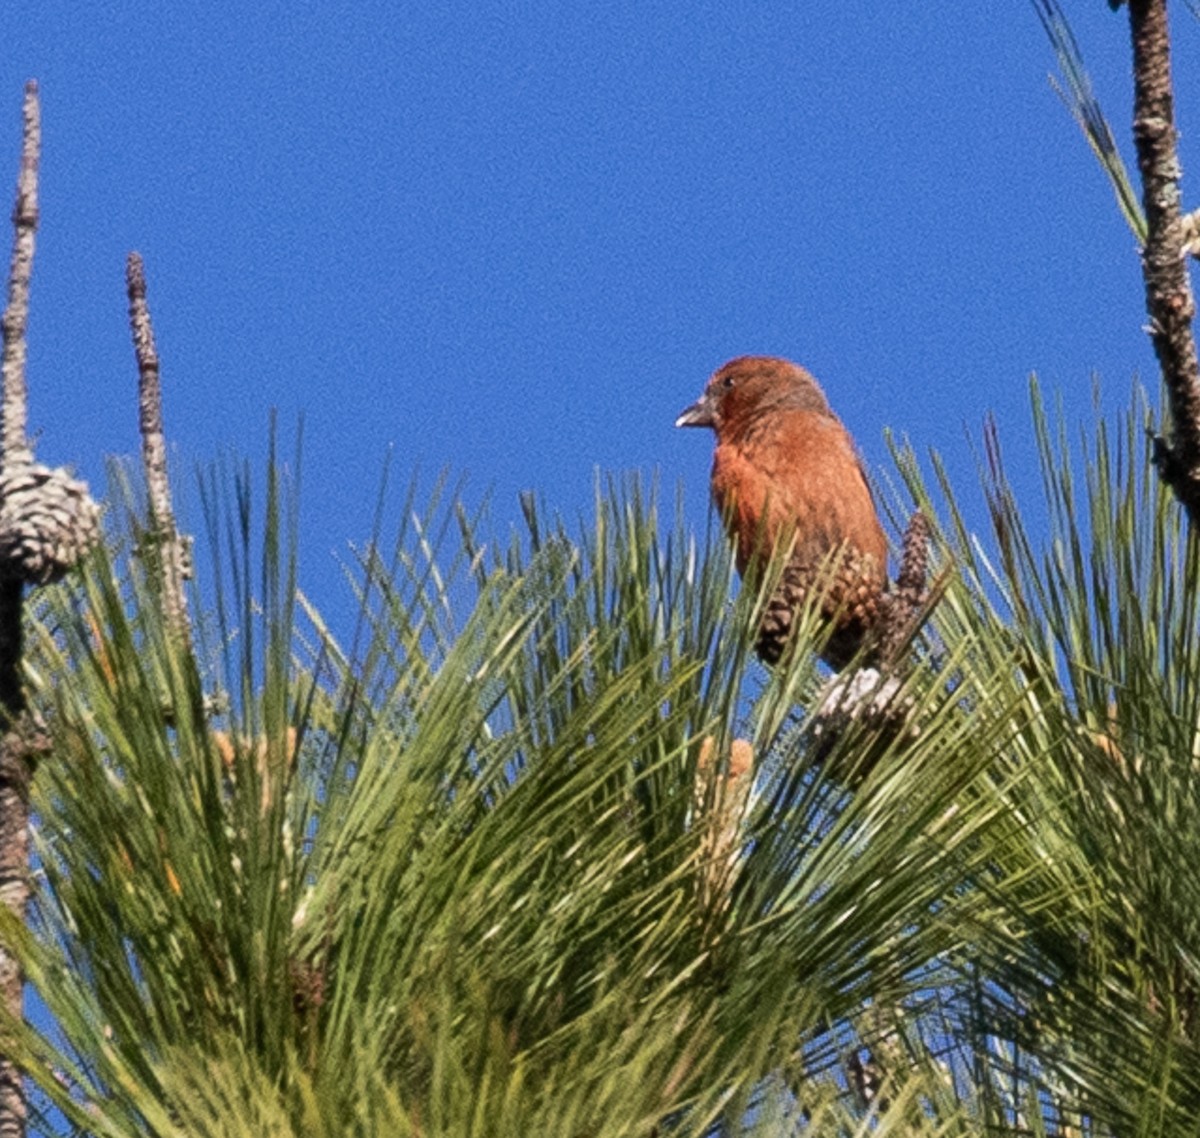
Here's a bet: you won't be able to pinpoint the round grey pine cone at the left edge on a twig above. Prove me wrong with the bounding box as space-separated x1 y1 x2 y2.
0 462 100 585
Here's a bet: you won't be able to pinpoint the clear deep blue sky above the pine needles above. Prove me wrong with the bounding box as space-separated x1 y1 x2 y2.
0 0 1185 629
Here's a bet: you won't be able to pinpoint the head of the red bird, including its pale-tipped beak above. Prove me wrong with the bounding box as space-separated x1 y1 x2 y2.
676 355 832 437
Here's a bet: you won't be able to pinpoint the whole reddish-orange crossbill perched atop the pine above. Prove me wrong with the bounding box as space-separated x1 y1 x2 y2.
676 355 888 670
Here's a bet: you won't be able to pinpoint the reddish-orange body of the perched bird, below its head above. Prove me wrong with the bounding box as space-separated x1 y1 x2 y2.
713 411 887 573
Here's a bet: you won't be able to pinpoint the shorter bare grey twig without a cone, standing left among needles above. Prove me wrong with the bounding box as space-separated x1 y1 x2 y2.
125 253 191 640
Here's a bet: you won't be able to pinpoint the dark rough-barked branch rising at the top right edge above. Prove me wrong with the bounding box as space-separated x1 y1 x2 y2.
1129 0 1200 527
